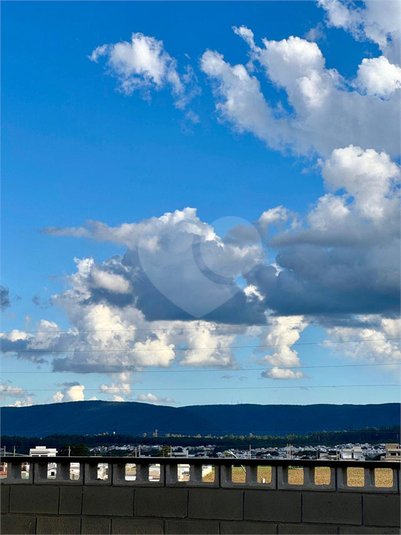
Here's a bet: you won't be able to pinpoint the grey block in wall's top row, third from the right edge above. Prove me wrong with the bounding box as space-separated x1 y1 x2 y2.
245 490 301 522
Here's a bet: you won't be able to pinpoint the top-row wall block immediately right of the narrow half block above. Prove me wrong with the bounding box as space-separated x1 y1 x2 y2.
82 486 134 516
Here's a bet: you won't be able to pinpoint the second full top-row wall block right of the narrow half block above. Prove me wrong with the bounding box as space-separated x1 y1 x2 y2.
134 487 188 518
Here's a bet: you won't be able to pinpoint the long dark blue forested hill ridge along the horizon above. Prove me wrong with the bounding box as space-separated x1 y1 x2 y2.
1 401 400 437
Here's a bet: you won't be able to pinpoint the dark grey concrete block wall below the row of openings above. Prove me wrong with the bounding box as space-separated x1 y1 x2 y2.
1 482 400 535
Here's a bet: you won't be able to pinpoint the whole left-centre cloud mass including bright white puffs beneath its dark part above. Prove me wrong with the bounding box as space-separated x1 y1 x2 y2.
2 209 265 376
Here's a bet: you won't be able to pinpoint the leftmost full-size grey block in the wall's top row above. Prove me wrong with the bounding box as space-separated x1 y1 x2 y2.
10 485 59 515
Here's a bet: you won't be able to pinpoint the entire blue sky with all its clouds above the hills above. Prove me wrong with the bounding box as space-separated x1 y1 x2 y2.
0 0 401 405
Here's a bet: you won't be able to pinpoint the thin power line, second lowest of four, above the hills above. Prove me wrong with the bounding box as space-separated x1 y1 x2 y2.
3 361 401 375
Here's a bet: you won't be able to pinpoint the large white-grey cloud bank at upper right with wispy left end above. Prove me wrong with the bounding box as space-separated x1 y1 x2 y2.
201 27 400 157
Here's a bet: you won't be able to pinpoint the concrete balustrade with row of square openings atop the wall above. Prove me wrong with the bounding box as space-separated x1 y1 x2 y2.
0 456 400 493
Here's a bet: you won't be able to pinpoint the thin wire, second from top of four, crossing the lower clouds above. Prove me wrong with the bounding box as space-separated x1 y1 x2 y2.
0 337 401 353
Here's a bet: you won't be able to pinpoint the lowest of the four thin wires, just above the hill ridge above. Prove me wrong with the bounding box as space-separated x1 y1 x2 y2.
6 384 401 394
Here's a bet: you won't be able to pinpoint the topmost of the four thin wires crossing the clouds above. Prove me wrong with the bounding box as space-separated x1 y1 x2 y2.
0 316 394 335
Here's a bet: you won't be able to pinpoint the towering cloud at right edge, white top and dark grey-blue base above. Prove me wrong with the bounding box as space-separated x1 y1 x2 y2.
246 146 400 315
